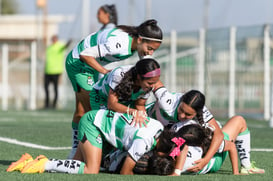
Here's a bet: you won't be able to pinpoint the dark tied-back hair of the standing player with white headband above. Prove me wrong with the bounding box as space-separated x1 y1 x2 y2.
117 19 163 41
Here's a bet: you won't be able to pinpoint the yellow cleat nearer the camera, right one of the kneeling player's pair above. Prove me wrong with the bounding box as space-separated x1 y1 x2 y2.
21 155 48 173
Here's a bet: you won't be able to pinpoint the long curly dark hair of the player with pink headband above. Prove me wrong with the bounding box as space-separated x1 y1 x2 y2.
114 58 160 101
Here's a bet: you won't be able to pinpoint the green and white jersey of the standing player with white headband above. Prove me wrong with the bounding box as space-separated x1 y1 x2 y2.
72 28 134 66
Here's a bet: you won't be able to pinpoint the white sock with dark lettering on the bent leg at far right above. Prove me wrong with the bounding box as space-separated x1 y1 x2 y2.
235 129 251 168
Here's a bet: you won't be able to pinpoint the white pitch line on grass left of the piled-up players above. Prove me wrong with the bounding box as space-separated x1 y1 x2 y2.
0 137 71 150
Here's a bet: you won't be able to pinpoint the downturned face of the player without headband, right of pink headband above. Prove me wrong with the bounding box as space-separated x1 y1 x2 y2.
177 102 196 121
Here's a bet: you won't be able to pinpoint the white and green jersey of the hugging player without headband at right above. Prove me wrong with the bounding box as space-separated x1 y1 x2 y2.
147 87 213 125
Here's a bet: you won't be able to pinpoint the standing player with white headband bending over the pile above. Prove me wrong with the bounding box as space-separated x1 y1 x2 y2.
66 20 163 158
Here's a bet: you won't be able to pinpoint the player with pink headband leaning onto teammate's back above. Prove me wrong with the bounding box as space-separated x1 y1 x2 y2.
90 58 160 126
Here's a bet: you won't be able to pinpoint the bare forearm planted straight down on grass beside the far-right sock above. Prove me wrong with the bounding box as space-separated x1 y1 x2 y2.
224 140 239 175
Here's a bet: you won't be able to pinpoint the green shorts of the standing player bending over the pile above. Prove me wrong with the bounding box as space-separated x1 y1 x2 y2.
65 51 99 92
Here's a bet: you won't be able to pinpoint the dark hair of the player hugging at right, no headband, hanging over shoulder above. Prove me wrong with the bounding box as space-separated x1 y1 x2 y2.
180 90 206 125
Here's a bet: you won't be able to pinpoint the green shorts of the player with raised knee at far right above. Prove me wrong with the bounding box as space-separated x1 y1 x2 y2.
205 132 229 173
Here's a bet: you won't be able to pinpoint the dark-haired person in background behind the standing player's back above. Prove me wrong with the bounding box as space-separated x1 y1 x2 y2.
97 4 118 30
